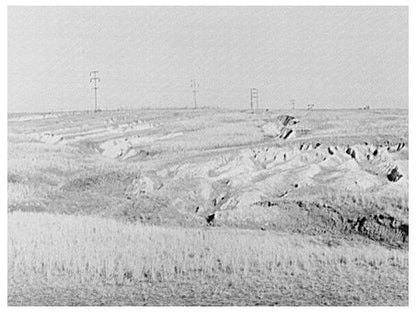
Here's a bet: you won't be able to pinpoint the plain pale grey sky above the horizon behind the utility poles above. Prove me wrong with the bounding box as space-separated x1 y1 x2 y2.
8 6 408 112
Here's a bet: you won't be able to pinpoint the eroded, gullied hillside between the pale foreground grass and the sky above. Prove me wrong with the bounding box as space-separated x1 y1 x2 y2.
8 109 409 304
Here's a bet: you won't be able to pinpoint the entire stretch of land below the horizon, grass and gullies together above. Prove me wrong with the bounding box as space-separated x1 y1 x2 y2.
8 109 408 305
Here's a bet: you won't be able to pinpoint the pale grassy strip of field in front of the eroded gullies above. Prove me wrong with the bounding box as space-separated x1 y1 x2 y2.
8 212 408 305
